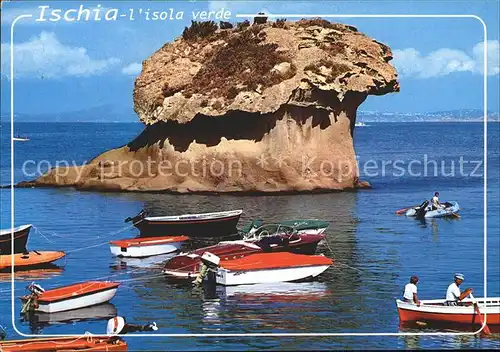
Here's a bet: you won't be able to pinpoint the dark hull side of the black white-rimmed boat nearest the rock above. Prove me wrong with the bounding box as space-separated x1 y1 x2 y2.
135 214 241 237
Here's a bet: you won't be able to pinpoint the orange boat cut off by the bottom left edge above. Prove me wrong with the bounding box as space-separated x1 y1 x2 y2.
0 335 127 352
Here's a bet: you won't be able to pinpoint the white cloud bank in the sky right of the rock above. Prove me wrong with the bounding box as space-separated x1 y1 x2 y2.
393 40 500 78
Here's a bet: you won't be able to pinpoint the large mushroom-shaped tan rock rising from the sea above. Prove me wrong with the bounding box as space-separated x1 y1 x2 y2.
26 19 399 192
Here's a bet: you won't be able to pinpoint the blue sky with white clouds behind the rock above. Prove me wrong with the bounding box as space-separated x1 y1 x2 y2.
1 0 500 120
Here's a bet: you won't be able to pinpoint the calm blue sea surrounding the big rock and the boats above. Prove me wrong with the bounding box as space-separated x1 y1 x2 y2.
0 123 500 350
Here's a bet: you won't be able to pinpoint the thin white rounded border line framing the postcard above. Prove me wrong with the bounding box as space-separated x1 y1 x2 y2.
10 8 488 338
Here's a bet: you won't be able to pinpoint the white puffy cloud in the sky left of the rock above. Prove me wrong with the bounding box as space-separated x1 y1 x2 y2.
1 31 120 79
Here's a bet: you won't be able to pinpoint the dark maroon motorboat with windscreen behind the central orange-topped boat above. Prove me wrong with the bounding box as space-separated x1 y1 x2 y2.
163 224 325 279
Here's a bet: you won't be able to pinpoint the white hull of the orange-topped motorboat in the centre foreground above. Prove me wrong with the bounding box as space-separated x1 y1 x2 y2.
216 265 330 286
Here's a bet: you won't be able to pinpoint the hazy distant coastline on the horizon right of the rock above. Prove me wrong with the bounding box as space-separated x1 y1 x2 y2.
357 109 500 122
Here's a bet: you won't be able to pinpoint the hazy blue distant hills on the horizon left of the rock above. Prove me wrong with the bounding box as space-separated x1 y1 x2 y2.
1 105 137 122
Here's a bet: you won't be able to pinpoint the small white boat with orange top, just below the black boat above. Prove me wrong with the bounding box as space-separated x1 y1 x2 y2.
109 236 189 258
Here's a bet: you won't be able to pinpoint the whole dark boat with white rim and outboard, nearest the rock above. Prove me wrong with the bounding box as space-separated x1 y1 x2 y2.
125 210 243 237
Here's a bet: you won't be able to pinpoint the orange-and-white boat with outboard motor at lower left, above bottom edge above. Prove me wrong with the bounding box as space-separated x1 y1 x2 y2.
20 281 120 313
